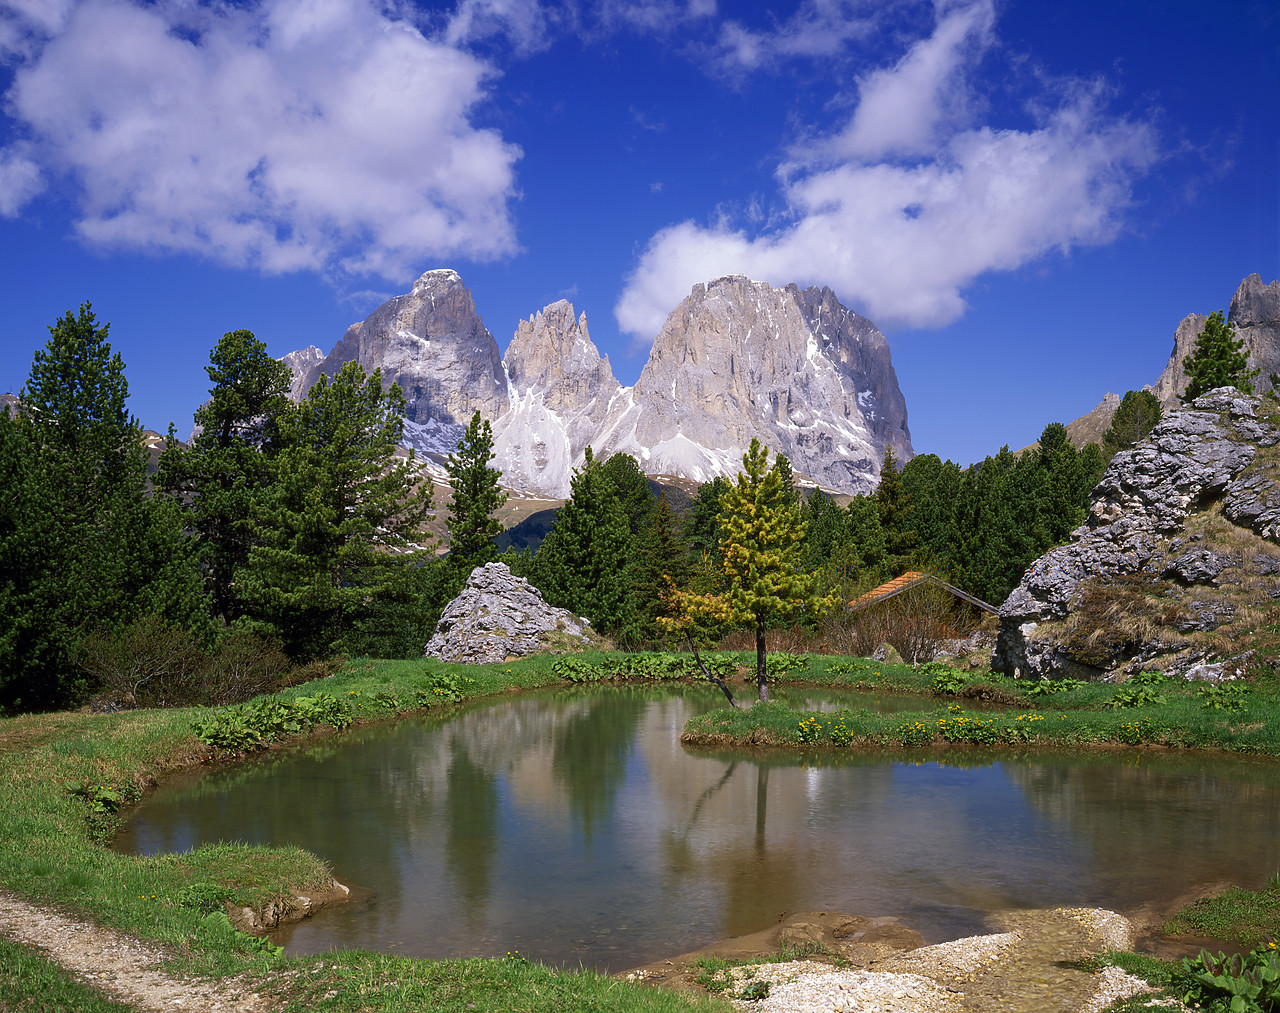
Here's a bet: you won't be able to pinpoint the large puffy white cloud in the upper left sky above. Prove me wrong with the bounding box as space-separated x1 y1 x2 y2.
6 0 520 280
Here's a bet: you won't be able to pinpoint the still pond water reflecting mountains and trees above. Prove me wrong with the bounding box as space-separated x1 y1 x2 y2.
115 686 1280 971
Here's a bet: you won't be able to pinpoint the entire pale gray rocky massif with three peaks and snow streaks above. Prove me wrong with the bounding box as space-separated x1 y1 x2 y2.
284 270 913 497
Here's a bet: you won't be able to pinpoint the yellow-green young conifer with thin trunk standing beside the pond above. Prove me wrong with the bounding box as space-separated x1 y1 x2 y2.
668 438 836 701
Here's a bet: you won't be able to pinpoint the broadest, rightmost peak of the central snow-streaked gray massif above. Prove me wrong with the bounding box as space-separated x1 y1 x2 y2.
588 275 911 493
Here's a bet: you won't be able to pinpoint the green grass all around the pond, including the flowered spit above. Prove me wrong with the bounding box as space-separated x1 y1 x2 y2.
0 653 1280 1013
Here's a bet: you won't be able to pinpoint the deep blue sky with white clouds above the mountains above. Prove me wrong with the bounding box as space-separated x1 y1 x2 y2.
0 0 1280 462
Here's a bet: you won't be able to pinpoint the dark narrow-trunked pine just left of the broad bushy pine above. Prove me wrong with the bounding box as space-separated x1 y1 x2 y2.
157 330 292 622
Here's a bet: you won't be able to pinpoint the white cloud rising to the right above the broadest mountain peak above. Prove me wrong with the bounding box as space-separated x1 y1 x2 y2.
614 0 1158 342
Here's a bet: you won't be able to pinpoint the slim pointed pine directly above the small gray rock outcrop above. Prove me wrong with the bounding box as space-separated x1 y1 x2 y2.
445 411 507 580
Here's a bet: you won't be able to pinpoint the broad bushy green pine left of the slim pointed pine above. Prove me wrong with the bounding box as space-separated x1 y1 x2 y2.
237 362 433 657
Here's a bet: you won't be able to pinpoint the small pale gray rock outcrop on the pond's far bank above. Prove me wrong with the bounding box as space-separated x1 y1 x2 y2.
422 562 599 665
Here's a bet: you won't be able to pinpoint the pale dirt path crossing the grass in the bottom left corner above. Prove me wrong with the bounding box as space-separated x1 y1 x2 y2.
0 890 278 1013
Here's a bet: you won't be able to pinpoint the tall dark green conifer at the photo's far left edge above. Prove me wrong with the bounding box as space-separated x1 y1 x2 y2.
0 302 207 709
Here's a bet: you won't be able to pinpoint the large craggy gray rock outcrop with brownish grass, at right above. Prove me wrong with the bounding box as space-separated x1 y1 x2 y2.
992 387 1280 679
